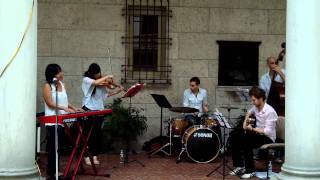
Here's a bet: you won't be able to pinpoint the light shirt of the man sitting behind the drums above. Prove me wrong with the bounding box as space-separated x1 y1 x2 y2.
183 88 208 113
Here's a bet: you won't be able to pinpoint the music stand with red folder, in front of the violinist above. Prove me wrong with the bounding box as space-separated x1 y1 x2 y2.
122 83 146 167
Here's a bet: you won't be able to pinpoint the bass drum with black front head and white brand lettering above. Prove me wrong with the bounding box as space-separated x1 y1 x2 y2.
182 125 220 163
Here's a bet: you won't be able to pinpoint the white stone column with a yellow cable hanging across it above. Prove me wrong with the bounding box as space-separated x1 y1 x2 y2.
0 0 39 179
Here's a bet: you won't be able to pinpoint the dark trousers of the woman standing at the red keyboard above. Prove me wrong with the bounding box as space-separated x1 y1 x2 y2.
46 126 64 176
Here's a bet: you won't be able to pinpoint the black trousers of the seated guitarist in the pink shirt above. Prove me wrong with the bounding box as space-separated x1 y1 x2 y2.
229 129 273 173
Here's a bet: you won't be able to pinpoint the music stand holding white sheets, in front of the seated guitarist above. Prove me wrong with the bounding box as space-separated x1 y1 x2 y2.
207 109 232 180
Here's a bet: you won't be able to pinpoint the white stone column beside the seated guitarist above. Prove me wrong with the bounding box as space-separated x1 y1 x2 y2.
275 0 320 180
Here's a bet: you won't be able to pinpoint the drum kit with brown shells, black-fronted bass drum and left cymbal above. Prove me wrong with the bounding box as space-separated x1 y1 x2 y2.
168 107 221 163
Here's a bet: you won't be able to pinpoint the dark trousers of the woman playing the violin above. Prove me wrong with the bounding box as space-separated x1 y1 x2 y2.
82 107 104 156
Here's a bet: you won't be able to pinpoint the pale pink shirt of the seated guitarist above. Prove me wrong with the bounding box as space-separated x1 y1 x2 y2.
249 103 278 142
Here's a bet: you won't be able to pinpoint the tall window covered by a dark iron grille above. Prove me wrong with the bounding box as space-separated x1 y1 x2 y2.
121 0 172 84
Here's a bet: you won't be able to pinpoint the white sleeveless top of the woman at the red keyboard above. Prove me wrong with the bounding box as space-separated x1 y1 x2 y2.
44 81 69 126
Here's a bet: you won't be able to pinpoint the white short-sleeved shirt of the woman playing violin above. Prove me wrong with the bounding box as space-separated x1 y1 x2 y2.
82 77 107 110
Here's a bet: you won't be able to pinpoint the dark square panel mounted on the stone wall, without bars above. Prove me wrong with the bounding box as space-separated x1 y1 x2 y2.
217 41 261 86
